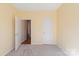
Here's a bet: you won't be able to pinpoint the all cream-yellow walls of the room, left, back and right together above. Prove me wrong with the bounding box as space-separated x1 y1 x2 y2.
0 4 79 55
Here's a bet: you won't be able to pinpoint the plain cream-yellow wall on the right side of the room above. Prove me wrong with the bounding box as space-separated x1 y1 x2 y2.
57 4 79 55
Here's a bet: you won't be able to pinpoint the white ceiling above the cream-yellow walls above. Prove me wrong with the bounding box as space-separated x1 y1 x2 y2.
13 3 62 11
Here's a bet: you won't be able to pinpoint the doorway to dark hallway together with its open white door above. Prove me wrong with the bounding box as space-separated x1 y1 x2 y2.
15 17 31 50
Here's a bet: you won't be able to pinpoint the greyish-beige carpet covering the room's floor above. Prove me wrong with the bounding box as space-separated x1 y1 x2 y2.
6 45 66 56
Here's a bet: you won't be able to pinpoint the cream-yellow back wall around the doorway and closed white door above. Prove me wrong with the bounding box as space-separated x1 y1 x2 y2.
16 11 57 44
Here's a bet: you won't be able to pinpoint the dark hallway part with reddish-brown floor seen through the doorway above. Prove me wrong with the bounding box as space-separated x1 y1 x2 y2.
22 20 31 44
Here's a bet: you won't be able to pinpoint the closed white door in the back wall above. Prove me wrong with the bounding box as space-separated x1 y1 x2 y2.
42 18 53 44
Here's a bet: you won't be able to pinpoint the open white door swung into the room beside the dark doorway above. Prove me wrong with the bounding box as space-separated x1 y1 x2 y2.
15 17 21 50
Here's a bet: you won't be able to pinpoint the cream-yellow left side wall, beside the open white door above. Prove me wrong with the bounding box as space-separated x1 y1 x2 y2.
0 4 16 55
